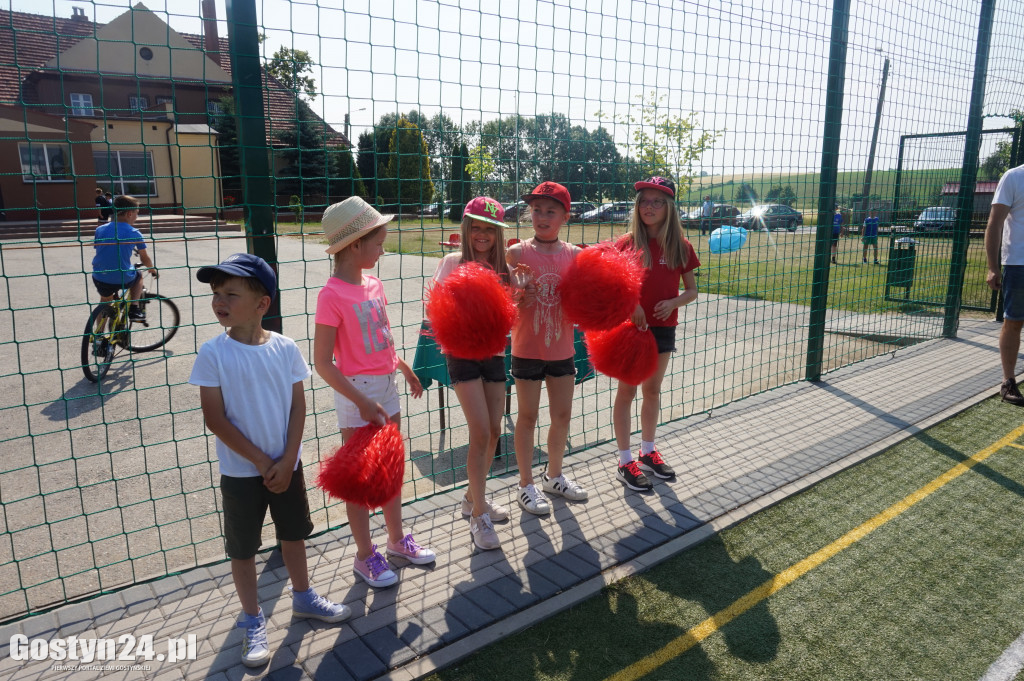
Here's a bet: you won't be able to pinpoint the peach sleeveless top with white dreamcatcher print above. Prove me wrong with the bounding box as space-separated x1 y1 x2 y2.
512 239 577 361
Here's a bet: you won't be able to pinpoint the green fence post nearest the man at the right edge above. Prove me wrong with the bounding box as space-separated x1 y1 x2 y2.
942 0 995 338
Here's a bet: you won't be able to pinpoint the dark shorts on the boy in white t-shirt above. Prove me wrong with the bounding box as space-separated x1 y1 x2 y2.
220 464 313 560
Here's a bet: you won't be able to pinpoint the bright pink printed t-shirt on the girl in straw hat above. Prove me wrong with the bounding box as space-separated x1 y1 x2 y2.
315 274 398 376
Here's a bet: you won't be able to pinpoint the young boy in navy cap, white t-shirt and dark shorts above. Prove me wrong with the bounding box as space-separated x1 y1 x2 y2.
188 253 350 667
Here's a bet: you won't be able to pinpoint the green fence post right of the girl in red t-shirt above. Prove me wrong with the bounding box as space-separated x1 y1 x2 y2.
805 0 850 381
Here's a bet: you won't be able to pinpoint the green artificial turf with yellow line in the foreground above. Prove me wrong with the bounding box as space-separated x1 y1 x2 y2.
430 398 1024 681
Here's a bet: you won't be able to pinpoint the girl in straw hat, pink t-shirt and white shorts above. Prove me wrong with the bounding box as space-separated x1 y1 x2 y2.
313 197 435 587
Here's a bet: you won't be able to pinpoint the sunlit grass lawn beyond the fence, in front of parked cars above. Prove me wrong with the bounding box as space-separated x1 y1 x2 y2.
280 219 991 315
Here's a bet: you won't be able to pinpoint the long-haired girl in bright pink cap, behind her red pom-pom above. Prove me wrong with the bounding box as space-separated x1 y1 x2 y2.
433 197 520 549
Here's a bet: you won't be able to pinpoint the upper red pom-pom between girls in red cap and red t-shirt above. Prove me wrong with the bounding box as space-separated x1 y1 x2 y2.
558 242 644 331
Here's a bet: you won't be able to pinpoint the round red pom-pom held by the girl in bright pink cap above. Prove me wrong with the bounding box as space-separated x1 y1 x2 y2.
424 262 516 359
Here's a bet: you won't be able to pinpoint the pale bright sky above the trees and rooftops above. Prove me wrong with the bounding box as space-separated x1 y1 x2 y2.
8 0 1024 183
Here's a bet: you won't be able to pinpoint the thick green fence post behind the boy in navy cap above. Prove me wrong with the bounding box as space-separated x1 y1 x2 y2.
225 0 282 333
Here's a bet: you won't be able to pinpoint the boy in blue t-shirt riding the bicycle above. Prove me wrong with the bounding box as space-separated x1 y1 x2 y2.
92 196 159 322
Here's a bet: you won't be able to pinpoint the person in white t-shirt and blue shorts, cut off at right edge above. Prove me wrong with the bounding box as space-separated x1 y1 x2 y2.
985 166 1024 407
